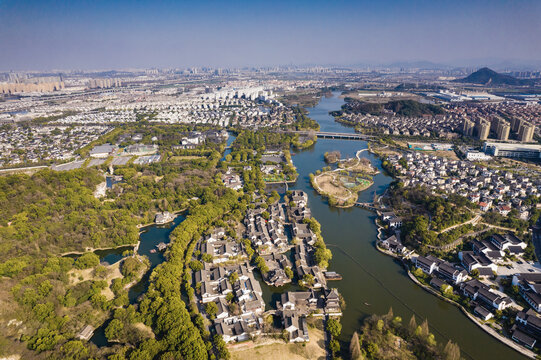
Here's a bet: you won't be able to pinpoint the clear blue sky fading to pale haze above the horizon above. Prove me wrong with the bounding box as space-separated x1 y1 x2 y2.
0 0 541 71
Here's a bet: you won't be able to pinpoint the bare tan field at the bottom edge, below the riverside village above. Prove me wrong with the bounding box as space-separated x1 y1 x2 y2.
229 328 326 360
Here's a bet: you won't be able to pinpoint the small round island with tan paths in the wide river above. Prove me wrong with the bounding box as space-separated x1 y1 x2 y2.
310 150 378 207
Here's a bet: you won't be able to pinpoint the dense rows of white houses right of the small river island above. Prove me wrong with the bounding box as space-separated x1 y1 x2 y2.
388 152 541 220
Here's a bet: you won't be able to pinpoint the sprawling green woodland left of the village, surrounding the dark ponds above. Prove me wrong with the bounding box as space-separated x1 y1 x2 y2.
0 129 234 359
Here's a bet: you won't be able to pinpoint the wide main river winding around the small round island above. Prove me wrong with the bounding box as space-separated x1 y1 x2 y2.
290 93 526 360
